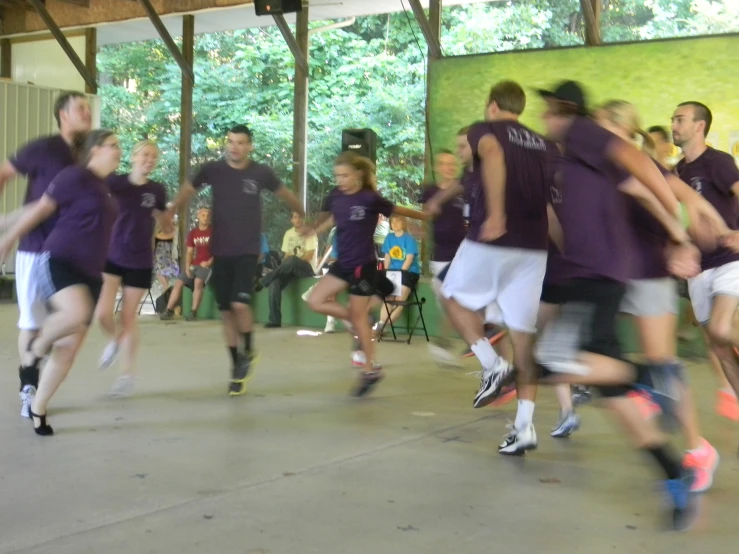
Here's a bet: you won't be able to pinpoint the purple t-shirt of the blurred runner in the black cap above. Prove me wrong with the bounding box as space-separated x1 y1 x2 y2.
557 117 634 283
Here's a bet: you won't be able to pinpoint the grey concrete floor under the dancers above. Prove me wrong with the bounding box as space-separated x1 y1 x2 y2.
0 305 739 554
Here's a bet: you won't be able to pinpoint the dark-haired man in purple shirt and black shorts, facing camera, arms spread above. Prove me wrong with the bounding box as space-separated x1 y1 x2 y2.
172 125 305 396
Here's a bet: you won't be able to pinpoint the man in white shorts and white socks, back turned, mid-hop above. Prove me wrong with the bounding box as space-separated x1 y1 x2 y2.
429 81 552 453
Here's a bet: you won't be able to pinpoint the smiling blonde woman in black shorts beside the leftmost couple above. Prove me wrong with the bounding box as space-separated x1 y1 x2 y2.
96 140 171 396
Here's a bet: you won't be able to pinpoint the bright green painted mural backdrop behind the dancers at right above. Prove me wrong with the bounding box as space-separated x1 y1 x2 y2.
429 37 739 150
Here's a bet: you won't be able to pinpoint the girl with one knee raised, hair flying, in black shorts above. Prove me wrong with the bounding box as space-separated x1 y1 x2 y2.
308 152 426 397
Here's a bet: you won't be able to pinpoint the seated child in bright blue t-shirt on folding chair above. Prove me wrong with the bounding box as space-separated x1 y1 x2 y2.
376 215 421 335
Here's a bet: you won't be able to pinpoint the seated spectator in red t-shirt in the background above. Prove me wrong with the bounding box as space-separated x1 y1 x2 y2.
161 208 213 321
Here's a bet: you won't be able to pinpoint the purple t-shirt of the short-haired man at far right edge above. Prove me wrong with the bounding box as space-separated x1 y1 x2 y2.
675 148 739 270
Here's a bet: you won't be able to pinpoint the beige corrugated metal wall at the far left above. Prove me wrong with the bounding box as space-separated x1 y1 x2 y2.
0 81 100 273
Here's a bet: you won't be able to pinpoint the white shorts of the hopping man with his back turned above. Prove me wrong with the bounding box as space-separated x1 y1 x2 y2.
441 239 547 333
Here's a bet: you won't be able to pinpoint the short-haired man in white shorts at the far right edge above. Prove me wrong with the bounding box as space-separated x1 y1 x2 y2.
672 102 739 416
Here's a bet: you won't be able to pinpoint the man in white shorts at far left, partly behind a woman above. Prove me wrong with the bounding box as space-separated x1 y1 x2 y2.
0 91 92 417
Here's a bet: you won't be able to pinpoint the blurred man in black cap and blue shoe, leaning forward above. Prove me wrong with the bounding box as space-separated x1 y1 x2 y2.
535 81 697 529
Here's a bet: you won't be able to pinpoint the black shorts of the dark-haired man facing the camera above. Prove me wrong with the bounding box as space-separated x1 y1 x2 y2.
210 254 259 312
